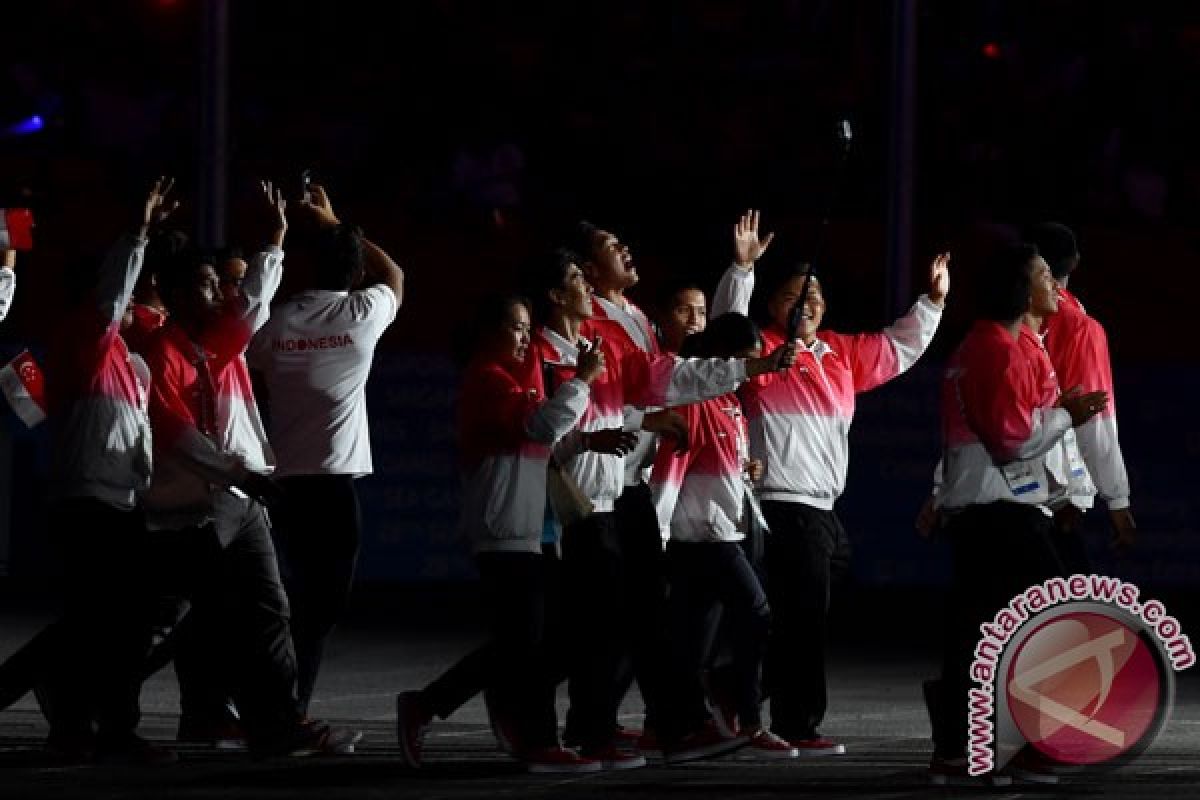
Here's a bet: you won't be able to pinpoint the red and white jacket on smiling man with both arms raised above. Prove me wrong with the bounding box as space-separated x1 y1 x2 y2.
713 266 942 511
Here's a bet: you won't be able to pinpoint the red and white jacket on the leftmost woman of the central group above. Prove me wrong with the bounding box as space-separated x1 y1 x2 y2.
458 350 589 553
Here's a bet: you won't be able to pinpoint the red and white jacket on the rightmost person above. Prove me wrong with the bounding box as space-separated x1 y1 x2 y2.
1045 289 1129 510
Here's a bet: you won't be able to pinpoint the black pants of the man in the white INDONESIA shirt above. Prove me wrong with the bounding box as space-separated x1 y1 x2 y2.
274 475 362 714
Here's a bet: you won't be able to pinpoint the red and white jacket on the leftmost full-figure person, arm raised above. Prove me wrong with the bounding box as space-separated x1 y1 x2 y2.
46 235 152 510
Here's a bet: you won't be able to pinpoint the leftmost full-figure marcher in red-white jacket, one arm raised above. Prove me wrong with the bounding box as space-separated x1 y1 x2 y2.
29 179 174 762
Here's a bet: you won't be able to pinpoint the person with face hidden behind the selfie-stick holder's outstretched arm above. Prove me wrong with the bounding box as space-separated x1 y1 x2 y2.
650 312 799 760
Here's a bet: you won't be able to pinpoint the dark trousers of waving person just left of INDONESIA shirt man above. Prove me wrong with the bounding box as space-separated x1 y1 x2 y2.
151 500 300 750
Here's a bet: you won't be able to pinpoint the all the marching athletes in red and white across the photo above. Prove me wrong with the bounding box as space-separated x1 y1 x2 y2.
0 182 1134 782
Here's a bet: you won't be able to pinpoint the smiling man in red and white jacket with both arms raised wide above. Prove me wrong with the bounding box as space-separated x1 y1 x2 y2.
713 216 949 754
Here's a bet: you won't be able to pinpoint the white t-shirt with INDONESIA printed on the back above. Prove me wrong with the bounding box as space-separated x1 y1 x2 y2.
246 284 398 476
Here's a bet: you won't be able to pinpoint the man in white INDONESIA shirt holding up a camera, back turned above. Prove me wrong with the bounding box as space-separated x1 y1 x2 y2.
247 184 404 714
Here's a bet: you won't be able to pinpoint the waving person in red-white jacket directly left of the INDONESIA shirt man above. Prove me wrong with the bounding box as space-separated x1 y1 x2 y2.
145 184 361 757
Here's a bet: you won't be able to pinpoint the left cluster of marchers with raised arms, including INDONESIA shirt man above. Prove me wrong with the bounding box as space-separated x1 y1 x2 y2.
0 179 403 764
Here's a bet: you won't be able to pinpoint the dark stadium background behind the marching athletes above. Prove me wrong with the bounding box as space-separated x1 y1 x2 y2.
0 0 1200 618
